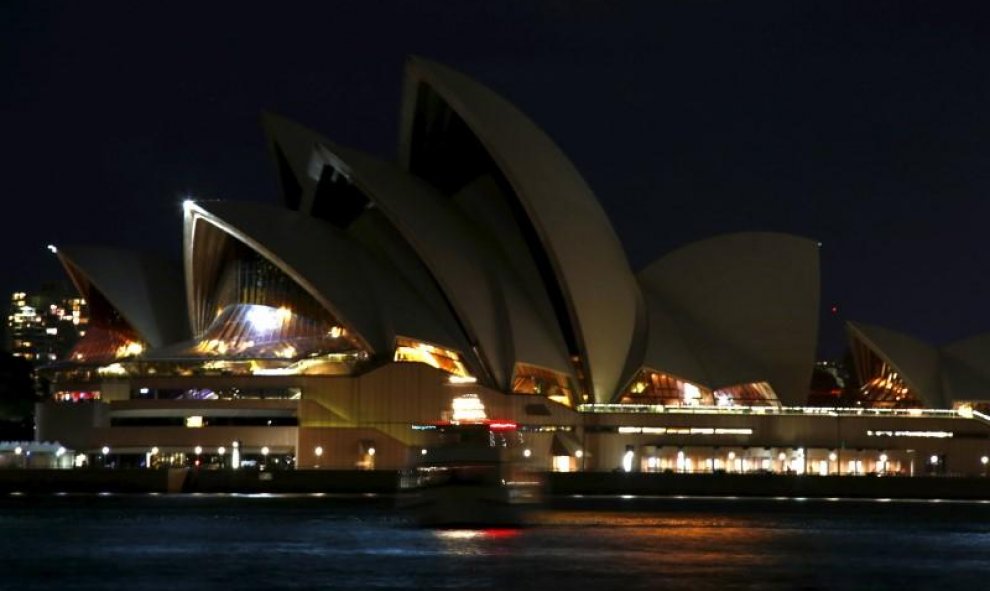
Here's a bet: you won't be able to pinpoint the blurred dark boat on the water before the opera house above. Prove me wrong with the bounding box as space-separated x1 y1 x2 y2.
405 395 543 527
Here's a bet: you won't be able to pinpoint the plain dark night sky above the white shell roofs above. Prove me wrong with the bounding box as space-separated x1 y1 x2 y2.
0 0 990 354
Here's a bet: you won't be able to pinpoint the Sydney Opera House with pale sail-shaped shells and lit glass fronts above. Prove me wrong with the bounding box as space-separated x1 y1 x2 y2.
31 58 990 474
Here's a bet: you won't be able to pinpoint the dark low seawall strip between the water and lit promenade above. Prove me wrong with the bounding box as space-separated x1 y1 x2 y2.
0 470 990 501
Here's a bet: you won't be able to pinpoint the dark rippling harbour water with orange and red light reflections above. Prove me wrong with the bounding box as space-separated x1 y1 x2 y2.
0 495 990 591
